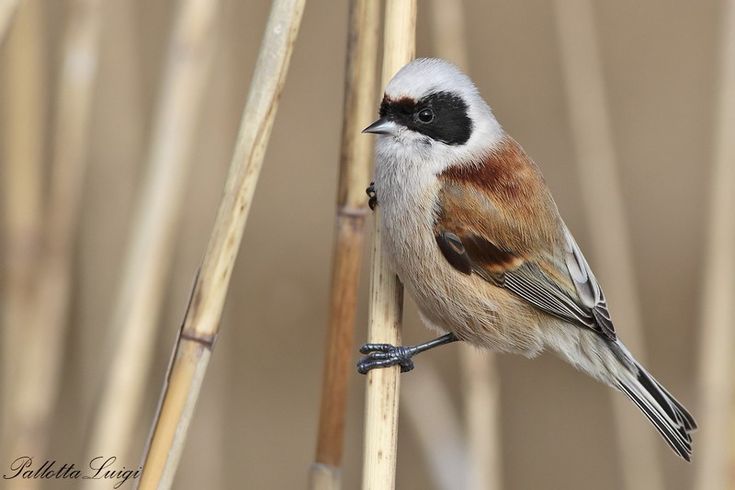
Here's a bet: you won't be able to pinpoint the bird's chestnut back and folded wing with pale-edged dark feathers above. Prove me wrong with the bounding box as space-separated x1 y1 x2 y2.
434 135 617 340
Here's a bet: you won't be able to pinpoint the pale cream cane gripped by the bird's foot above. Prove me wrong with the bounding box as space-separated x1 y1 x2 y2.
362 0 416 490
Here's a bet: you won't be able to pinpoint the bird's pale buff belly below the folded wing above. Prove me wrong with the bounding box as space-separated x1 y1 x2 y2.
379 186 542 355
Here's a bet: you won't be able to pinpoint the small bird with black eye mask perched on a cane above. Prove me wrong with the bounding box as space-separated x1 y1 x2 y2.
357 58 697 461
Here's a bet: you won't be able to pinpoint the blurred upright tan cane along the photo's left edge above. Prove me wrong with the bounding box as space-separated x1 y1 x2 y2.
0 0 44 470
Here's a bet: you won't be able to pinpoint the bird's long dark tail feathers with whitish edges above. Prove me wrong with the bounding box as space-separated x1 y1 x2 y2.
611 342 697 461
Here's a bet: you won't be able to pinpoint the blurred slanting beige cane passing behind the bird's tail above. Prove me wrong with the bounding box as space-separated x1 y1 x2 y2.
555 0 664 490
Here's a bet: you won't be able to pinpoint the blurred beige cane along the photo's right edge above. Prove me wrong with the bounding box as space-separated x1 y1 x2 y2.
695 0 735 490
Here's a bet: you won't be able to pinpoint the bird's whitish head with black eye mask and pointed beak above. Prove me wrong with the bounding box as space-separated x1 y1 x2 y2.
364 58 503 172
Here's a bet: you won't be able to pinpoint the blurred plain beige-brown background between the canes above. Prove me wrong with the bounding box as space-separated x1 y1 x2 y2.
0 0 722 490
